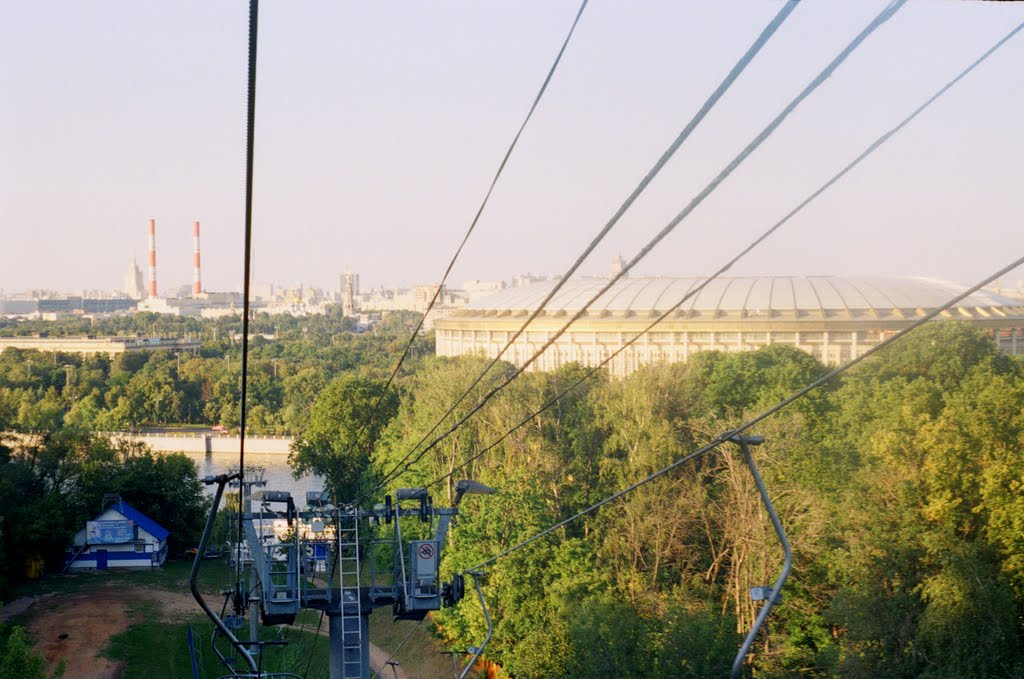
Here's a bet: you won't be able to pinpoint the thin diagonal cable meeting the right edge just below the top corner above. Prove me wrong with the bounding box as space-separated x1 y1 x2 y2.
427 13 1024 487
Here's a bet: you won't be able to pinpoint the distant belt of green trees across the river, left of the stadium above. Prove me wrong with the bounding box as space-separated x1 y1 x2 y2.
0 313 431 433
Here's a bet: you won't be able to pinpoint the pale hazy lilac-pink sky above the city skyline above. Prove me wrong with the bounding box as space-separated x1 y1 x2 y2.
0 0 1024 292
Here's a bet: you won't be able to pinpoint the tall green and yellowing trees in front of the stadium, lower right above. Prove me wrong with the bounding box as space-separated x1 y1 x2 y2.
364 323 1024 679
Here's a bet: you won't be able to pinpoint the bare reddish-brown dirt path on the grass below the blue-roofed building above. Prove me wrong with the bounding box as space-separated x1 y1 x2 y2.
0 587 414 679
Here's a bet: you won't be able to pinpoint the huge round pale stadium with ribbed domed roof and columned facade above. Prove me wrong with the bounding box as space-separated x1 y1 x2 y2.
434 275 1024 376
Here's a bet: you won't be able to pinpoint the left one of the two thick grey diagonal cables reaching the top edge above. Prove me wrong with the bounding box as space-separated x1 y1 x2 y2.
359 0 799 500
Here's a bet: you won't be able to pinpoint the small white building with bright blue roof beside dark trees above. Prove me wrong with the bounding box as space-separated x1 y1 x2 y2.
67 500 169 571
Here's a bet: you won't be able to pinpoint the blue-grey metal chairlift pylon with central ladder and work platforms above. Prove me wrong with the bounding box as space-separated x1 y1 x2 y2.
189 474 496 679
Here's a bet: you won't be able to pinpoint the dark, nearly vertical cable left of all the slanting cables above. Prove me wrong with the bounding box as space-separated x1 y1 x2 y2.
234 0 259 589
